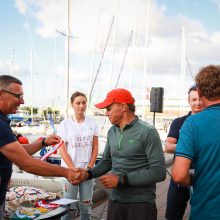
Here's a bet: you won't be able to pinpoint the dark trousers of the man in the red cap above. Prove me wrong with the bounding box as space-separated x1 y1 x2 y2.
107 200 157 220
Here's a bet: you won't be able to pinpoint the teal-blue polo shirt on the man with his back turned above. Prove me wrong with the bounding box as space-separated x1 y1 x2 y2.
176 104 220 220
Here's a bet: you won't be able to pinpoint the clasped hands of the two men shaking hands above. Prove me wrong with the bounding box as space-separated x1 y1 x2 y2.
66 168 89 185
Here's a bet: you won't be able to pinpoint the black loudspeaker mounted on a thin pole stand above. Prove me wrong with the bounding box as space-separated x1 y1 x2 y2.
150 87 164 113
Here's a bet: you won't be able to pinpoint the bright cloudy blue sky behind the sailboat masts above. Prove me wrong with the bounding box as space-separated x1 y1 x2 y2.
0 0 220 108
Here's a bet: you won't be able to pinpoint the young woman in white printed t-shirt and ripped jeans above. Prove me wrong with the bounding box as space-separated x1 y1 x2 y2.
58 92 98 220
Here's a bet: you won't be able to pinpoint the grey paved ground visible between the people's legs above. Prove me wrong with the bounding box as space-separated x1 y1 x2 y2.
76 155 190 220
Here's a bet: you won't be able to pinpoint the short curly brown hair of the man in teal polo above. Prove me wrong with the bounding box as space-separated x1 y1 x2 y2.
195 65 220 101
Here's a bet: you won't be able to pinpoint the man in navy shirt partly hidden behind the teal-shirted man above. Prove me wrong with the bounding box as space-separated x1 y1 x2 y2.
165 85 203 220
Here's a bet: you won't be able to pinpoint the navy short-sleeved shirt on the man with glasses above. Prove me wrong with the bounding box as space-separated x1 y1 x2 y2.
0 112 16 205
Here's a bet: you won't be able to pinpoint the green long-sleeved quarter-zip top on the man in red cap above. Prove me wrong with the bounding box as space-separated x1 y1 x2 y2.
92 117 166 204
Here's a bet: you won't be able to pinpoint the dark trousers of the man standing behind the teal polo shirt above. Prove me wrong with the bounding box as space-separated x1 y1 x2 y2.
165 179 190 220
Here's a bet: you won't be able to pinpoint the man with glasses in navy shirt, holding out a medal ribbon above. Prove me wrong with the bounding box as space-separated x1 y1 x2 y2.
0 75 79 220
